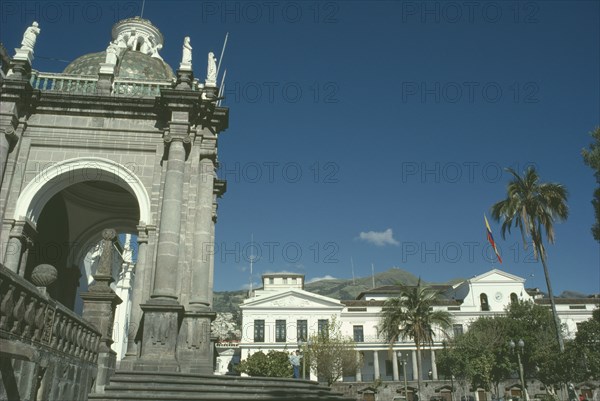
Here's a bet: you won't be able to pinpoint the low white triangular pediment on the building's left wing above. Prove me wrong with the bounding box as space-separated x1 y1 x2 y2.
241 289 344 310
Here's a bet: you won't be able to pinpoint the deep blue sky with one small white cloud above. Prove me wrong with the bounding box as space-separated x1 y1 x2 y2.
0 1 600 293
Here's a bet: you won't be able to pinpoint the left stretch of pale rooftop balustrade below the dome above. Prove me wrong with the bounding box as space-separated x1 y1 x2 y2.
31 71 98 95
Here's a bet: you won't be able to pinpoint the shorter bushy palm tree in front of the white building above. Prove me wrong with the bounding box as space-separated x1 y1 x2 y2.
379 278 452 393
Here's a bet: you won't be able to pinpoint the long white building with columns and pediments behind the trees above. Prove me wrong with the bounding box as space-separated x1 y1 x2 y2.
240 269 600 382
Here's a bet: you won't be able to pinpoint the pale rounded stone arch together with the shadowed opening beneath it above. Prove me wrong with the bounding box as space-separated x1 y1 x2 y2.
7 157 152 309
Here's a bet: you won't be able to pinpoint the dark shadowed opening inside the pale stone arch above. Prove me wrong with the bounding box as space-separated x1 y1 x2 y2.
25 181 140 312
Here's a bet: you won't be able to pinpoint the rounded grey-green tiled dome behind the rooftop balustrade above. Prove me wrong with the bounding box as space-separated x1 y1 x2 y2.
63 49 175 80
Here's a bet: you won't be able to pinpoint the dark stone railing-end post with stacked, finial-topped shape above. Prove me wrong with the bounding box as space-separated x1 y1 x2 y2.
81 229 122 392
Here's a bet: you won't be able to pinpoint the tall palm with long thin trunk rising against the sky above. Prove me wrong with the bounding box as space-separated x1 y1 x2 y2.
491 167 569 352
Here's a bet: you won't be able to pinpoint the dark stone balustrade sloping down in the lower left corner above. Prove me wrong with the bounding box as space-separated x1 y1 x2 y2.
0 265 102 401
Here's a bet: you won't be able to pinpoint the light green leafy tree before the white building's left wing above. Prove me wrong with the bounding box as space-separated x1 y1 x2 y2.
303 317 361 386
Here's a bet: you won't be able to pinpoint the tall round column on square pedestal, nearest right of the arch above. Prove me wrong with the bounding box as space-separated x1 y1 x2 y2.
134 76 195 372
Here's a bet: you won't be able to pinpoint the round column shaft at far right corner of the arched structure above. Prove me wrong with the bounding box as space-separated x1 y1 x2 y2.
190 147 216 310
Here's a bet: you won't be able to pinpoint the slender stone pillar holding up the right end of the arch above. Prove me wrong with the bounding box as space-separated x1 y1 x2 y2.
120 226 150 370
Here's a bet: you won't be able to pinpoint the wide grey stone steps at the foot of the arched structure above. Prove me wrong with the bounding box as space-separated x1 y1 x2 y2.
88 371 349 401
